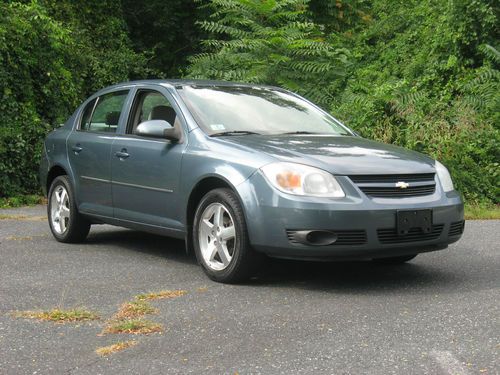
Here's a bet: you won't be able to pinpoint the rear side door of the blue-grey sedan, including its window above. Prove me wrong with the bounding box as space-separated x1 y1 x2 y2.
67 90 129 217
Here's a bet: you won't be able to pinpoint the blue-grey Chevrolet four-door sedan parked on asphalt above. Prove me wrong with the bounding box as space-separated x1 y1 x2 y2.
40 80 464 283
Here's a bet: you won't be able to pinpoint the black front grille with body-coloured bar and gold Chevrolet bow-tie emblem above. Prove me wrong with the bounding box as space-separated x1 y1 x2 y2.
349 173 436 198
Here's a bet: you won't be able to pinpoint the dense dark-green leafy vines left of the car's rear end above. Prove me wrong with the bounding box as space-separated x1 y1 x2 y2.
0 1 144 198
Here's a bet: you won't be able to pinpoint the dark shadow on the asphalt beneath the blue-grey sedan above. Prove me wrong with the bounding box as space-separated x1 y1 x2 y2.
87 229 466 294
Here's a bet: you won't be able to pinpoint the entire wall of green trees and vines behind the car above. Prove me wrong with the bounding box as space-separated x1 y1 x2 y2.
0 0 500 205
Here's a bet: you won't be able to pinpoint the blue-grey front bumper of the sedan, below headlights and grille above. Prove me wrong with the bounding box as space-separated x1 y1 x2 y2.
237 172 464 260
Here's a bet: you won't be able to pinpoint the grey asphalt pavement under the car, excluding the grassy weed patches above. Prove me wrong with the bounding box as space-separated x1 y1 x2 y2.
0 206 500 375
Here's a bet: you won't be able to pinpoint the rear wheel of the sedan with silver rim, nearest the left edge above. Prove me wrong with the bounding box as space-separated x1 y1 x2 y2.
47 176 90 243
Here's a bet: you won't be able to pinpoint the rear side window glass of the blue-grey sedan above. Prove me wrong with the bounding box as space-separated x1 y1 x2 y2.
80 91 128 133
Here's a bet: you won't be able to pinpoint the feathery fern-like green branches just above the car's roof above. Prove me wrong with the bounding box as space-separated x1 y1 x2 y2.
189 0 348 104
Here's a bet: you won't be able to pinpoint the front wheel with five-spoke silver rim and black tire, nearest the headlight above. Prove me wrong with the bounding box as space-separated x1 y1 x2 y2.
193 189 263 283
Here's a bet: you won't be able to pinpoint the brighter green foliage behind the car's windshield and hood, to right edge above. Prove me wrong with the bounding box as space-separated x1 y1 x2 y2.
190 0 500 202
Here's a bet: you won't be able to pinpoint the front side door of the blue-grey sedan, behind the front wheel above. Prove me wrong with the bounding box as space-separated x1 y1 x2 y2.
111 88 186 231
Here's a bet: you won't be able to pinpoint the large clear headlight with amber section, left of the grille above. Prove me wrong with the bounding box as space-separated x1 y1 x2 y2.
261 163 345 198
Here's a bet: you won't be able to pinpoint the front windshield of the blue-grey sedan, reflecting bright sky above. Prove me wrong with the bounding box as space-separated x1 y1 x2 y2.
178 86 351 135
